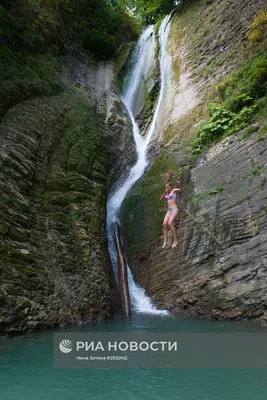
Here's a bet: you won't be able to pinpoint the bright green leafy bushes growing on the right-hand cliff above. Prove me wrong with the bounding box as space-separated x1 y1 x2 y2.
193 54 267 154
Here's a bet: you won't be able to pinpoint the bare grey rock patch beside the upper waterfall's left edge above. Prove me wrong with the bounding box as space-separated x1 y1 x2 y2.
62 49 136 188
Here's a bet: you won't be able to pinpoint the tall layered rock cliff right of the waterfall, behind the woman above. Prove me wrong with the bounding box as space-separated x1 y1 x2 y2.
121 0 267 322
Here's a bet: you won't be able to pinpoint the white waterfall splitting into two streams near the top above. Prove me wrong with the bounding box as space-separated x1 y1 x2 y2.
107 16 170 315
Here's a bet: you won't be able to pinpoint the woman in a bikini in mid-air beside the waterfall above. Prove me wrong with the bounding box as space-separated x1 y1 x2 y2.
160 170 181 249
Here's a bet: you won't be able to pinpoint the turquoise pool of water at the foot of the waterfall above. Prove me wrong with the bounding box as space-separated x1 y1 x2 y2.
0 315 267 400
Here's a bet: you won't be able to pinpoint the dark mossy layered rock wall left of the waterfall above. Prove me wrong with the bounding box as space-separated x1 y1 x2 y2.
0 90 114 332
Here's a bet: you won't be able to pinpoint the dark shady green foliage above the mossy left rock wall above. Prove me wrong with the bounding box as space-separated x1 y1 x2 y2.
0 0 138 117
